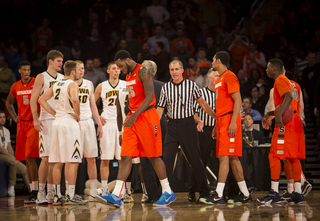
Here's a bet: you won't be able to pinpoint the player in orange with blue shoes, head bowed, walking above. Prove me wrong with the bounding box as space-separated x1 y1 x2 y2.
96 50 176 207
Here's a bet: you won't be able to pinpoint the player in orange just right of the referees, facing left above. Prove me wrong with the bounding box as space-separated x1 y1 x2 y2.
200 51 252 204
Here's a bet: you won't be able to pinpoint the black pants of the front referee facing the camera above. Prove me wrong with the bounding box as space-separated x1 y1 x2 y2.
163 117 210 197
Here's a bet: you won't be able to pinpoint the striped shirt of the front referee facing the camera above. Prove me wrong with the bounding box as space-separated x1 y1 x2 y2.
158 79 201 119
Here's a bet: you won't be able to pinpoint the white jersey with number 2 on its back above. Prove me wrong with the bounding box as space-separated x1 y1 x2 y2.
53 79 74 118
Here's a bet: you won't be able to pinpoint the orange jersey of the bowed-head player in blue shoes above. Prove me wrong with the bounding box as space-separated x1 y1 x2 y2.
126 64 156 111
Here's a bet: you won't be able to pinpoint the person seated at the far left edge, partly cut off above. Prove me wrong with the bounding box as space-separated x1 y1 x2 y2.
0 110 30 196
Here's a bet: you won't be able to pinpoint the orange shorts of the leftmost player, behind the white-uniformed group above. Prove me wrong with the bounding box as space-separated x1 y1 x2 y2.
16 120 39 161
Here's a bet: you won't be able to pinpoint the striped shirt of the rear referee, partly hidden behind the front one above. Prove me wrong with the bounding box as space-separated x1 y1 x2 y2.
194 87 215 126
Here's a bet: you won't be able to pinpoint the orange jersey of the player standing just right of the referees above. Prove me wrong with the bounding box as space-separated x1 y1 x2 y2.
215 70 240 116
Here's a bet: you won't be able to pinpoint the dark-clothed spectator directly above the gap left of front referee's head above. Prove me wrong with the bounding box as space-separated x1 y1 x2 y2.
154 42 169 81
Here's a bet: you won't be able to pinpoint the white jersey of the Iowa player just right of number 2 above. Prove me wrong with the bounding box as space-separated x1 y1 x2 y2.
79 79 93 120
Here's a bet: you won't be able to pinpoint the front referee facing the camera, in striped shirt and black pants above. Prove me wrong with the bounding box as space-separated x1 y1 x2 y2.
157 60 216 201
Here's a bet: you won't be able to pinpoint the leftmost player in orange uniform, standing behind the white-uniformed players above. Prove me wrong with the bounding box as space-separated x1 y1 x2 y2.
6 61 39 203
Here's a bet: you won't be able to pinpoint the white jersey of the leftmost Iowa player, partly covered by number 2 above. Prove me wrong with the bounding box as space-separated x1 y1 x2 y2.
39 71 64 120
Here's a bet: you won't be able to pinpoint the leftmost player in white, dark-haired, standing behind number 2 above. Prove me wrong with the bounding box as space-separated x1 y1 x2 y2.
30 50 64 204
